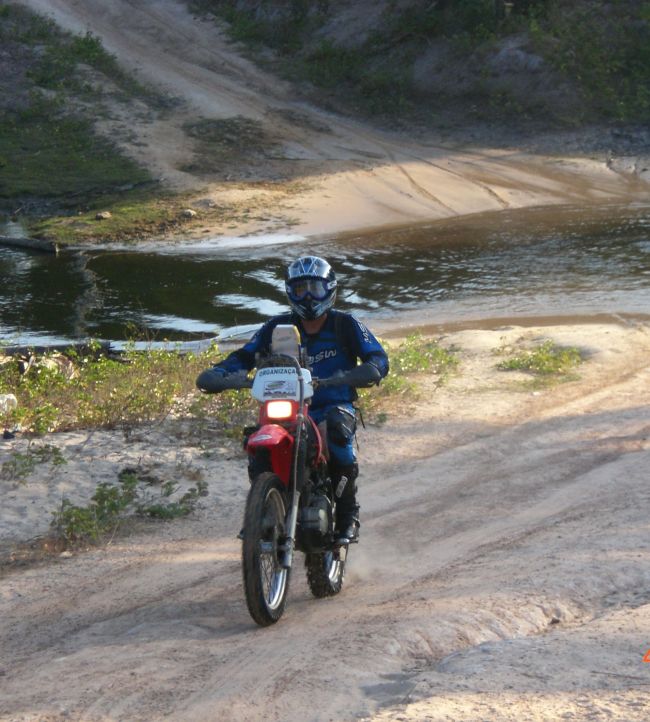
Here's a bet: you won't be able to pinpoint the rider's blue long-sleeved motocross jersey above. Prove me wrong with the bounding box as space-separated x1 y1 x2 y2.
217 309 388 409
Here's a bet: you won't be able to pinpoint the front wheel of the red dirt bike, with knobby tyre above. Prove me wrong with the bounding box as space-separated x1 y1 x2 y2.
242 472 289 627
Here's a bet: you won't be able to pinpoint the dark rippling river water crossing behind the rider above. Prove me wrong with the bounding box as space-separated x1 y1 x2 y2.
0 200 650 345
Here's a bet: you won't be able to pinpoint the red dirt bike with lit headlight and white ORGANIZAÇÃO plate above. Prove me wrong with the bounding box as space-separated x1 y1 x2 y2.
200 326 354 626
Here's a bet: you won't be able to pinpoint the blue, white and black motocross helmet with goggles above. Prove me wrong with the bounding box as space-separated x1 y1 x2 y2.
285 256 336 321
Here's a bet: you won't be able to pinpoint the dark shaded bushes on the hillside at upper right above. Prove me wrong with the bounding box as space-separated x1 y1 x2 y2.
192 0 650 122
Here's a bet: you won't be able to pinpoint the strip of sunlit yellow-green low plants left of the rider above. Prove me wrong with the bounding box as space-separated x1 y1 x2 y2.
0 338 253 435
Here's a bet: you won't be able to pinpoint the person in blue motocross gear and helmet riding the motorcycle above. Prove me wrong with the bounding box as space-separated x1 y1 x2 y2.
196 256 388 542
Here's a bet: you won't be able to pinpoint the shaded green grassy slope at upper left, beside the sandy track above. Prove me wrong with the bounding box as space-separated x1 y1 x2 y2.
0 3 157 217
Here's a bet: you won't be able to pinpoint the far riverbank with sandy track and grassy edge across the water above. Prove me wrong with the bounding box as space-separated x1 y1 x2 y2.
11 0 650 245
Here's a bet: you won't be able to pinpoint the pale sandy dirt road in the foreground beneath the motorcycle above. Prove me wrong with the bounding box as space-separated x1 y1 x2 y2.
0 325 650 722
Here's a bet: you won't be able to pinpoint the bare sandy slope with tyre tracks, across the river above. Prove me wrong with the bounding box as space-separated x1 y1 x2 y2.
15 0 647 235
